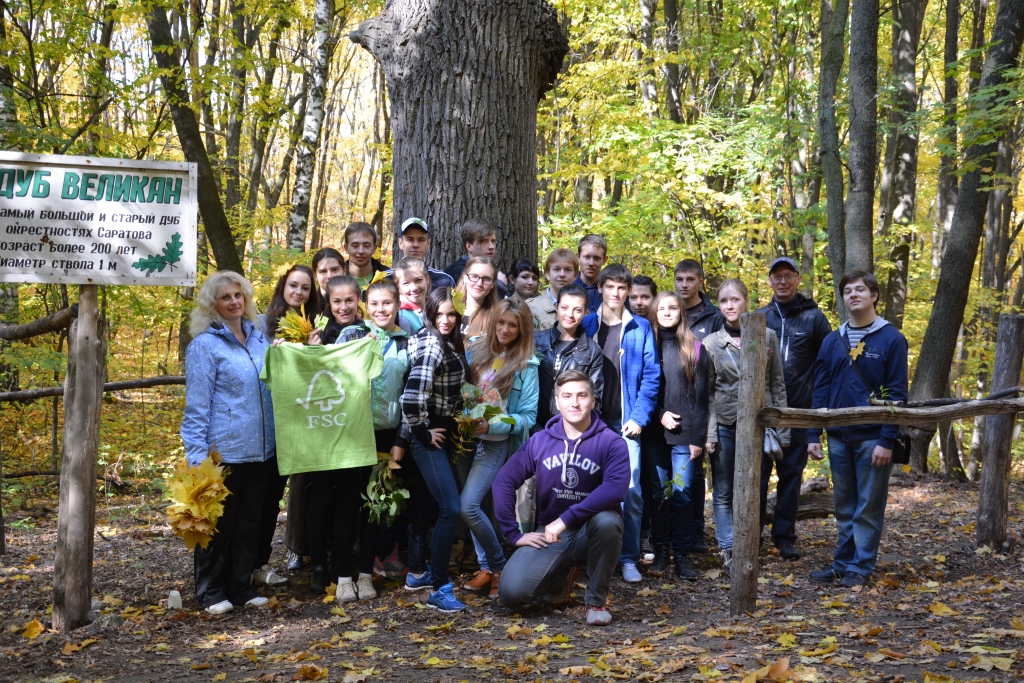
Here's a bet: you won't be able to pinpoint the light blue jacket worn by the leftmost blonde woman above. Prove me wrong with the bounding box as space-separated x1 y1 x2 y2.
181 321 275 465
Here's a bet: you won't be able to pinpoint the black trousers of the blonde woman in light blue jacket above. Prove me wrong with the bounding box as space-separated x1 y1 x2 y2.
193 458 278 607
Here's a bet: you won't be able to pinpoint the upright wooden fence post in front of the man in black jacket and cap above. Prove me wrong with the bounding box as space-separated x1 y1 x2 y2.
729 312 768 616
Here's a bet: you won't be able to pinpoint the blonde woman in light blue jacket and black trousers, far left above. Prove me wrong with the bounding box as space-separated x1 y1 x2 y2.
181 270 278 614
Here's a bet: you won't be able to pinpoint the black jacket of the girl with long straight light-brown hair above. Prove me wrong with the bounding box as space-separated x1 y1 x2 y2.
653 328 710 447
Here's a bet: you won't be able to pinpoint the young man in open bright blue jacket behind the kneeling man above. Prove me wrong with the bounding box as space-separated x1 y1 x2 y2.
583 263 662 583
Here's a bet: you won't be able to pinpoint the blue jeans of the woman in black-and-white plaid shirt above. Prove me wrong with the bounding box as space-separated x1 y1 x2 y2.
412 438 462 591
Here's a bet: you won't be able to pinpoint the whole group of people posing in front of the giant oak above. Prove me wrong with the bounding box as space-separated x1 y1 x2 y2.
181 218 907 625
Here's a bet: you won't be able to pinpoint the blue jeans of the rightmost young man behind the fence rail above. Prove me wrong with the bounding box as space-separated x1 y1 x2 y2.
828 436 892 577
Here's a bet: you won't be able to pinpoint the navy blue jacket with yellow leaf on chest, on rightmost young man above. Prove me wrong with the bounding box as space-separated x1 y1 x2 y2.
807 317 907 449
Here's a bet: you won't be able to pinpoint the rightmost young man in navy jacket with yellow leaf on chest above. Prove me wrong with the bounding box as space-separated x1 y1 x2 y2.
807 270 907 588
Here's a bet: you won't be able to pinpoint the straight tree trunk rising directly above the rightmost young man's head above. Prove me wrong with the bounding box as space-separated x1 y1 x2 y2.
846 0 879 272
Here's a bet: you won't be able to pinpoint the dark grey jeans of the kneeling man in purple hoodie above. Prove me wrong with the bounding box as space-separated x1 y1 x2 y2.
498 510 623 607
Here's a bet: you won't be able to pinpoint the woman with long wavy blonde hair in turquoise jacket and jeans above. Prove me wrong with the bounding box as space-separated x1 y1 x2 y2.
462 299 541 599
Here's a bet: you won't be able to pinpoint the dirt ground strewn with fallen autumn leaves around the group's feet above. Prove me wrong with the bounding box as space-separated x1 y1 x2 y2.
0 477 1024 683
